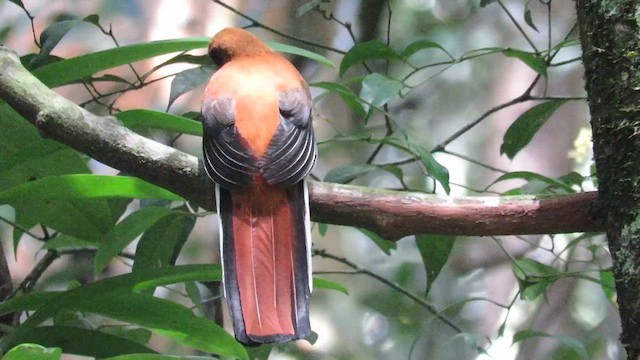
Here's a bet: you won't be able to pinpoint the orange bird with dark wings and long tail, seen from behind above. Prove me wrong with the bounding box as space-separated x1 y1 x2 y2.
202 28 317 345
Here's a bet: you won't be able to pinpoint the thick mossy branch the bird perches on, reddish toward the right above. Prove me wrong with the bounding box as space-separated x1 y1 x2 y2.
0 47 601 239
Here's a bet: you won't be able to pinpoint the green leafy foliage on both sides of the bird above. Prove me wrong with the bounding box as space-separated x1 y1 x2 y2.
0 0 614 360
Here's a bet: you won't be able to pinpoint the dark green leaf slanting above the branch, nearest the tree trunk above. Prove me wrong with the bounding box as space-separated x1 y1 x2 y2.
500 99 567 159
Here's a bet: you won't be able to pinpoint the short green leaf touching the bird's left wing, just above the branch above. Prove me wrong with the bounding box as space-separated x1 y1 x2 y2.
116 109 202 136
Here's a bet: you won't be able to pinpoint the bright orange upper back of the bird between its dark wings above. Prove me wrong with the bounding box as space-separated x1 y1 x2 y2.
205 53 306 158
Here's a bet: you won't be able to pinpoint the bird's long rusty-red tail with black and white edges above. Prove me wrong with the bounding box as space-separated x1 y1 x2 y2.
216 181 312 345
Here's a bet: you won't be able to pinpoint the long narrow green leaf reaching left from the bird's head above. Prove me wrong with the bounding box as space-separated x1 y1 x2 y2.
33 38 209 88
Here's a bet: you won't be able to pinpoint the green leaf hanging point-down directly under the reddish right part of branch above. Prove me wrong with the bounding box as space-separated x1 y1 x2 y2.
416 234 456 294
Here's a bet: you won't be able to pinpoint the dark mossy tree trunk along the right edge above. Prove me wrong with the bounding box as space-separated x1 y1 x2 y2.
577 0 640 359
